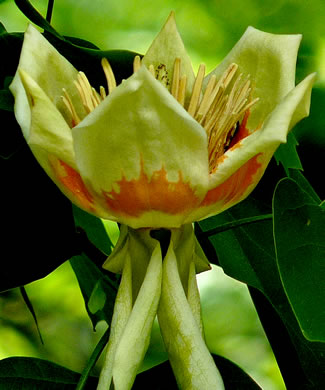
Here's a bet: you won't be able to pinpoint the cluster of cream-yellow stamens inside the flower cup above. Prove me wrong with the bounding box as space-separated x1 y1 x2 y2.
62 56 259 171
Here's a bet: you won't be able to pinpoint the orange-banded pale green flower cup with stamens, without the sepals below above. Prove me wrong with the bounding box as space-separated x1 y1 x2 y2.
10 13 315 229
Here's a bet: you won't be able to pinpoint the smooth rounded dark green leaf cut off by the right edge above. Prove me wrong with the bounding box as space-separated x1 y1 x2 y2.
273 179 325 342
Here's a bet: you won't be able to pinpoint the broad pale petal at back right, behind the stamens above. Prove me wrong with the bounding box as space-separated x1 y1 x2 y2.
206 27 301 130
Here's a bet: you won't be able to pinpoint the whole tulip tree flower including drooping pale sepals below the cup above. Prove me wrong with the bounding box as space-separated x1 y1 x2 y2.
11 13 315 390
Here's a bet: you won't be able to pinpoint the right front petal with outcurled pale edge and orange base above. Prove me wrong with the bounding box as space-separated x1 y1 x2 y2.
186 74 315 220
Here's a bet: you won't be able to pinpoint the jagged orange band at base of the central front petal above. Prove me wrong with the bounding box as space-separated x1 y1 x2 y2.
103 164 200 217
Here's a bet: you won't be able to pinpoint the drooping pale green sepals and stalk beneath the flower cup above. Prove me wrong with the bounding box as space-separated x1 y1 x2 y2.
98 224 223 390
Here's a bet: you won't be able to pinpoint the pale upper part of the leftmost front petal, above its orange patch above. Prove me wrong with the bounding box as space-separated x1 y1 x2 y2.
16 69 76 169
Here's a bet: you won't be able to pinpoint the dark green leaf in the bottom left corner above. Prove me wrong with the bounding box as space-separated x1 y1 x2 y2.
0 357 97 390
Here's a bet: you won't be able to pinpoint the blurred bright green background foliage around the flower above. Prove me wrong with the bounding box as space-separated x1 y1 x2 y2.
0 0 325 390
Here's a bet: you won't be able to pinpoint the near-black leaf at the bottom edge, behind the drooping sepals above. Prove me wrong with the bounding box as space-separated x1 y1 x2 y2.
132 355 261 390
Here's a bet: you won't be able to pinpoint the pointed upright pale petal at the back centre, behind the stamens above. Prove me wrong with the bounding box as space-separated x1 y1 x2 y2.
142 12 195 95
